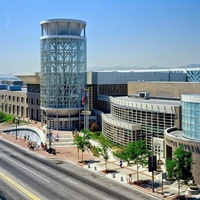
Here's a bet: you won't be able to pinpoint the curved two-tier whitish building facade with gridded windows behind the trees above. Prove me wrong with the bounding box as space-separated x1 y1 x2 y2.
102 94 181 157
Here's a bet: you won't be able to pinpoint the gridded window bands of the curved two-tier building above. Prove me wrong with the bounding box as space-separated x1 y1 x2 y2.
102 104 175 148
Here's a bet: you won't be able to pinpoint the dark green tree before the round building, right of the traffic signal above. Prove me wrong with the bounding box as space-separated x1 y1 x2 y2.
166 145 193 197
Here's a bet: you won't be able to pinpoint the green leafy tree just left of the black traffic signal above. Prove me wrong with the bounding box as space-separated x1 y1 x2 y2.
126 140 151 183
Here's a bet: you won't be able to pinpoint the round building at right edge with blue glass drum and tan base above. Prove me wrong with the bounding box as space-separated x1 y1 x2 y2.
165 94 200 184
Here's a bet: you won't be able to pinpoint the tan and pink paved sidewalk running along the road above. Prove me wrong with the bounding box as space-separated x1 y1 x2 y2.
0 123 200 200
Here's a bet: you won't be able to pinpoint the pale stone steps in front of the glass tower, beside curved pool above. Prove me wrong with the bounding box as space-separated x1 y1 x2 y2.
51 135 74 147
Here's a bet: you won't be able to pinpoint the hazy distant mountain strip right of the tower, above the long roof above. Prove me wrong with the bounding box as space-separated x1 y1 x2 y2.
88 64 200 71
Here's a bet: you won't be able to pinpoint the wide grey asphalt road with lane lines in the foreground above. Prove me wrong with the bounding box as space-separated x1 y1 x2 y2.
0 139 159 200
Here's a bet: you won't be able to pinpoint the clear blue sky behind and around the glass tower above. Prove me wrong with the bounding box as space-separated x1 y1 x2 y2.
0 0 200 74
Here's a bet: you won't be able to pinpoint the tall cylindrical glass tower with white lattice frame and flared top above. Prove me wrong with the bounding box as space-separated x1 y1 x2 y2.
40 19 86 130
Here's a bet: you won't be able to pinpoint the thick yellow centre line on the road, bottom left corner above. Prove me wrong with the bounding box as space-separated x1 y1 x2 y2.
0 172 41 200
